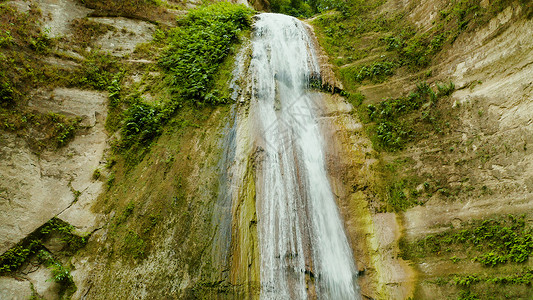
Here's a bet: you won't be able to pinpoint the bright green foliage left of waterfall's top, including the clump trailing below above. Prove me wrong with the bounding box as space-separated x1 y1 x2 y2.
122 2 253 155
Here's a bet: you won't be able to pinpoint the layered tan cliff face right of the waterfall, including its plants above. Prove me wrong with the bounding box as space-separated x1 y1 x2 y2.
313 1 533 299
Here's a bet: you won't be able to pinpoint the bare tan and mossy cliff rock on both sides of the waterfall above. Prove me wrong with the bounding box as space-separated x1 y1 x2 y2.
0 0 533 299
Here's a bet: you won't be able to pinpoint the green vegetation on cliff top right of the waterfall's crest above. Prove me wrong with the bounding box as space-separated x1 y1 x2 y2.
313 0 533 88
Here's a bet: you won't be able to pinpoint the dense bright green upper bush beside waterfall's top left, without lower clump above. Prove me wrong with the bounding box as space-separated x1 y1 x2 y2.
160 2 252 104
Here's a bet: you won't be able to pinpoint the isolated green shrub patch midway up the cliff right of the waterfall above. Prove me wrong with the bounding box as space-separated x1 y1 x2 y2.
364 82 455 151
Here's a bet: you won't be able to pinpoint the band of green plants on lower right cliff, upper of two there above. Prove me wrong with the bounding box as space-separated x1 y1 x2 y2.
401 215 533 267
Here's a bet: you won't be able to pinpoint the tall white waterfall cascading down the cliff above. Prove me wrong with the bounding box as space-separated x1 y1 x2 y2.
245 14 360 299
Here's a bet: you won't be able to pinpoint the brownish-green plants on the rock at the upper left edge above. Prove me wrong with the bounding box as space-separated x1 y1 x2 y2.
0 3 86 152
